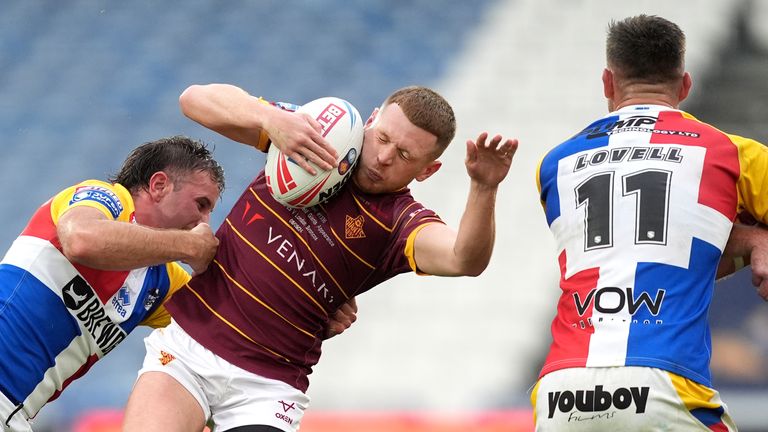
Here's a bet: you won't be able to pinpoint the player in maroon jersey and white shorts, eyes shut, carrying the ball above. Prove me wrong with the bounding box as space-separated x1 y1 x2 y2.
124 84 517 432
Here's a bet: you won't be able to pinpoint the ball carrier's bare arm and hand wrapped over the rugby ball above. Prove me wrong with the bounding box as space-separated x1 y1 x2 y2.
179 84 337 174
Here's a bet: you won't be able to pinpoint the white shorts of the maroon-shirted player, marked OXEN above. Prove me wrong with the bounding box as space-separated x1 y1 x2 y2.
139 321 309 432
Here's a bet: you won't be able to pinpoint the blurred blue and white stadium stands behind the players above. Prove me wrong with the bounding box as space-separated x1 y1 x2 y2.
0 0 768 432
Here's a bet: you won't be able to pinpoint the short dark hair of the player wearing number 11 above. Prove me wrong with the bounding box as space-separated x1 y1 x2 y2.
606 15 685 84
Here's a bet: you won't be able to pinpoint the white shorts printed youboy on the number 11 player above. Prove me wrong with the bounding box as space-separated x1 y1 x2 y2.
531 367 736 432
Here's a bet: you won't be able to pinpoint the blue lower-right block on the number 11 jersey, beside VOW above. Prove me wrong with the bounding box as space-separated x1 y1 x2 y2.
626 238 720 387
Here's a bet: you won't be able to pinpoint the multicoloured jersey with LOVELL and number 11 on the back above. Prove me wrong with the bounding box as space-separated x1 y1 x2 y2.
537 105 768 387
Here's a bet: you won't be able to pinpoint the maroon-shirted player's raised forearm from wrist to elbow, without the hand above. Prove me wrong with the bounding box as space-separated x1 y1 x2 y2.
454 182 497 276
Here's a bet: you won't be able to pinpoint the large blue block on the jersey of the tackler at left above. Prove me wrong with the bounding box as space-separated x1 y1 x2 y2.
0 264 80 404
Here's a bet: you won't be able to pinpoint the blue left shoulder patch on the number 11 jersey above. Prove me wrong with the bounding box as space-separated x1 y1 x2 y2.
539 116 619 225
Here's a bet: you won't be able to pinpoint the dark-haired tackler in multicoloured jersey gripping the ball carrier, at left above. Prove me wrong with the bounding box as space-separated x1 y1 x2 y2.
0 137 224 431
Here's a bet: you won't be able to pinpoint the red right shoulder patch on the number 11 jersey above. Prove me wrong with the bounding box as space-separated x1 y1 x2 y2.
651 111 739 220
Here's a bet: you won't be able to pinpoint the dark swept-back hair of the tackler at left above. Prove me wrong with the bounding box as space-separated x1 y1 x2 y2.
109 136 224 193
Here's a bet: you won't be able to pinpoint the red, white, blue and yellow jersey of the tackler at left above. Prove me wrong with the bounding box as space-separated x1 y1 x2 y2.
0 180 189 420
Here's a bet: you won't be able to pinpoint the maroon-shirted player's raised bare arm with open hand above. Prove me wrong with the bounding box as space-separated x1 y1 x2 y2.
414 132 518 276
